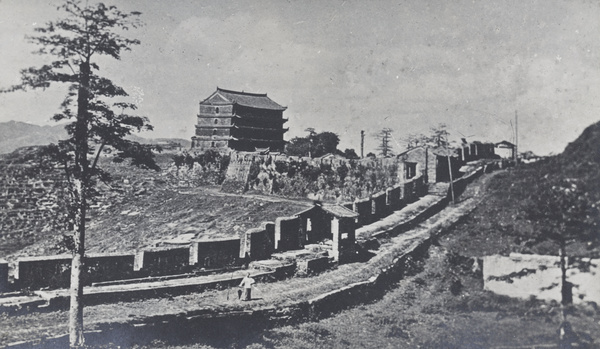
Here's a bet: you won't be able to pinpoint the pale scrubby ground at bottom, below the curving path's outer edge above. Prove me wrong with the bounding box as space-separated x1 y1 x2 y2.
132 172 600 349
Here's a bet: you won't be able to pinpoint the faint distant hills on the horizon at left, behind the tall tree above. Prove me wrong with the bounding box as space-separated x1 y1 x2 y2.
0 121 191 154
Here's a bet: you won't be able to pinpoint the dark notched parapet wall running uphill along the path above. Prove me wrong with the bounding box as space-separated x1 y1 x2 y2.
0 160 494 289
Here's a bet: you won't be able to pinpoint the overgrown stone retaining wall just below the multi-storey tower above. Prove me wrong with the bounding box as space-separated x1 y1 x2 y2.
221 152 399 201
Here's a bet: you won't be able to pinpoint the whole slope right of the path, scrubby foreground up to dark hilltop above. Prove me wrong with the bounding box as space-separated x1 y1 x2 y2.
243 123 600 348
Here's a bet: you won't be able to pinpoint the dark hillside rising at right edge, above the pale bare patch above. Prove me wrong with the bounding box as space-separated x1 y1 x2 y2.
453 122 600 258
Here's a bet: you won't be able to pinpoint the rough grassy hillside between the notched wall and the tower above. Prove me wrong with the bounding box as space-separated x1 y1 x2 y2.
0 148 310 258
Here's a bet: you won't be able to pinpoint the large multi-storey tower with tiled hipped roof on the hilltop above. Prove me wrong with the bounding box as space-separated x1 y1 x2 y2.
192 87 288 152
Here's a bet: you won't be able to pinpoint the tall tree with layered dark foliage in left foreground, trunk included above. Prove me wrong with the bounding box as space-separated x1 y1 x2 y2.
1 0 158 347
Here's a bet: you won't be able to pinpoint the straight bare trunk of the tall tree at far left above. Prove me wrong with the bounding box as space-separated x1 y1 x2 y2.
69 61 90 348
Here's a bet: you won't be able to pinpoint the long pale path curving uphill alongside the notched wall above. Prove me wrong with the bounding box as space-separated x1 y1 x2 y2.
0 168 488 348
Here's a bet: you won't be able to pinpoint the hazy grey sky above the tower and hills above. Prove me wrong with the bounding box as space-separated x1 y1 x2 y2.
0 0 600 155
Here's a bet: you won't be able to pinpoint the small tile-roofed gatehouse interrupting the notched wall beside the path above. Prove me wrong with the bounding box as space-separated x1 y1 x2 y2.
296 203 358 263
